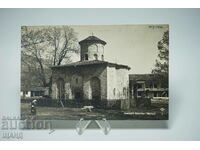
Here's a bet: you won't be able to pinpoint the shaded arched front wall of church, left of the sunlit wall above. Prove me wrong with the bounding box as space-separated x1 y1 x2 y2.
52 65 107 100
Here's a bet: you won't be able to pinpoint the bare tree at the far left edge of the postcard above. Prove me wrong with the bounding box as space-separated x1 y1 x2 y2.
21 27 47 87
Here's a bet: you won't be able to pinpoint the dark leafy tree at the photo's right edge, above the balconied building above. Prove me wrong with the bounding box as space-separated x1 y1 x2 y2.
152 31 169 87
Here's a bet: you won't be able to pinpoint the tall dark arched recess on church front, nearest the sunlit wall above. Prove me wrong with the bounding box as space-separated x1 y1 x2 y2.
90 77 101 100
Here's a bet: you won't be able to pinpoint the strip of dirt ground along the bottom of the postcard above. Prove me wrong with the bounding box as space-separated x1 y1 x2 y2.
21 103 168 120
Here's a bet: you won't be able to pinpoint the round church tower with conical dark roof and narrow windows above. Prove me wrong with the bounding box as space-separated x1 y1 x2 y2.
79 36 106 61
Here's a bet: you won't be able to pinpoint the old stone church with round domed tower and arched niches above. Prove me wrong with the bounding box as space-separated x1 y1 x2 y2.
51 36 130 108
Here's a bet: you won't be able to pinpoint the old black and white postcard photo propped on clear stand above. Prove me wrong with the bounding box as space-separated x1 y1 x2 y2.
20 24 169 120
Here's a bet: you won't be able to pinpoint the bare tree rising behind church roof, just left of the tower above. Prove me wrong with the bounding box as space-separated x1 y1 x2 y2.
45 26 79 66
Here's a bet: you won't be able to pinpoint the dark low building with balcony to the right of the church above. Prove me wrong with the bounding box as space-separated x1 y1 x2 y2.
129 74 169 107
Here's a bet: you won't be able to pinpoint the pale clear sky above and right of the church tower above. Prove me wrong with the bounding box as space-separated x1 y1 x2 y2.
71 25 168 74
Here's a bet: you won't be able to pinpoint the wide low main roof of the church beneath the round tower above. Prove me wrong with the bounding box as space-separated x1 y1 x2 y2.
51 60 131 70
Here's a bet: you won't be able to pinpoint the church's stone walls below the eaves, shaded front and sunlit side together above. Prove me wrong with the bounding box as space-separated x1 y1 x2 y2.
52 64 130 109
